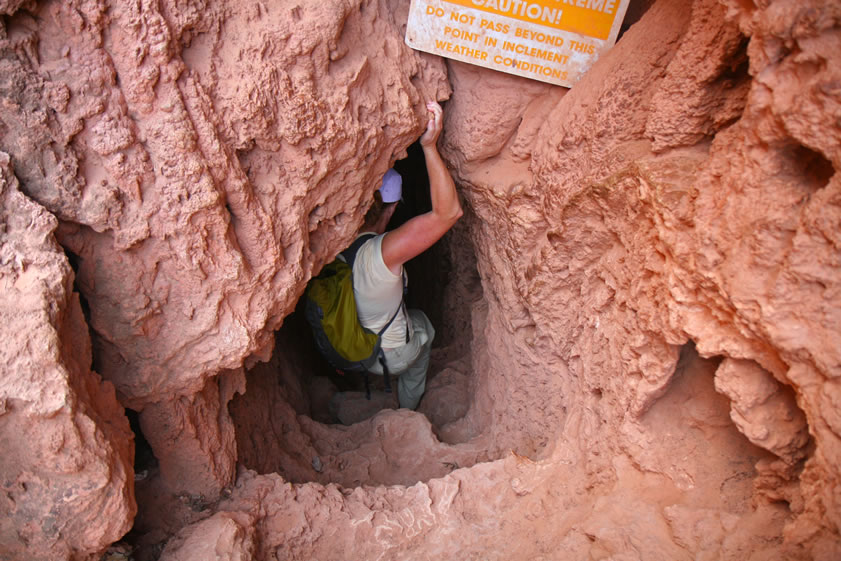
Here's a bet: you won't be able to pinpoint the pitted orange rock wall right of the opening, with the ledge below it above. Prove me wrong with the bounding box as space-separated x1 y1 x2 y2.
161 0 841 560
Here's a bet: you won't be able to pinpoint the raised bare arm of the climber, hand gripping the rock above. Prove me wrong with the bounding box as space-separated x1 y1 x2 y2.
382 101 463 275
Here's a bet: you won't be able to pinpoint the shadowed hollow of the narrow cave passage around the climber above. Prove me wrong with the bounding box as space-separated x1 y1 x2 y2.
228 143 492 487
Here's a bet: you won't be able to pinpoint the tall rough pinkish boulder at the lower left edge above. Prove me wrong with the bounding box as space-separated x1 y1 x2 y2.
0 152 136 561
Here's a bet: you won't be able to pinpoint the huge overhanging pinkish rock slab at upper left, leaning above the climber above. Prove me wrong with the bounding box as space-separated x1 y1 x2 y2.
2 2 449 409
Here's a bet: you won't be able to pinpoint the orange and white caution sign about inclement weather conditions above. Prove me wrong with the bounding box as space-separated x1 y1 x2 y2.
406 0 629 87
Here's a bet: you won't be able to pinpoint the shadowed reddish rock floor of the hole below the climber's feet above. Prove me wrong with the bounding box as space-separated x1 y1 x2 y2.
231 352 489 488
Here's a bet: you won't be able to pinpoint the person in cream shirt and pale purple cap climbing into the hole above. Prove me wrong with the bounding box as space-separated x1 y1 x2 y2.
353 101 462 409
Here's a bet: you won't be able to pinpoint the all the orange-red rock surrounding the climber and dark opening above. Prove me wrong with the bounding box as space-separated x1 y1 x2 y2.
0 0 841 561
